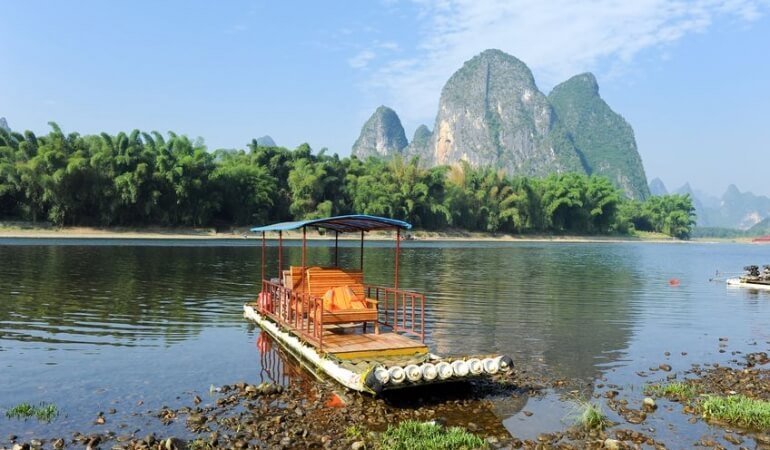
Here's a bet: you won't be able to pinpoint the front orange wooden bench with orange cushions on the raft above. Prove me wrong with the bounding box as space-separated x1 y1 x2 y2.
304 267 380 334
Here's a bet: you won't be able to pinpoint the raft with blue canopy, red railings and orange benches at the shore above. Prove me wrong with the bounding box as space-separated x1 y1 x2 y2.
243 214 513 395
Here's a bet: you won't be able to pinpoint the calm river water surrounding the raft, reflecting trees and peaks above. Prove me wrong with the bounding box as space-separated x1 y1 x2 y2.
0 239 770 442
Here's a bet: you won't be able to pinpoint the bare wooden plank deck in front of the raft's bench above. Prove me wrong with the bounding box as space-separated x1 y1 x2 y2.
316 326 428 359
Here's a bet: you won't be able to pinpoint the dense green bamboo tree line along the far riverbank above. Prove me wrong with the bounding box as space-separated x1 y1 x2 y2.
0 123 694 238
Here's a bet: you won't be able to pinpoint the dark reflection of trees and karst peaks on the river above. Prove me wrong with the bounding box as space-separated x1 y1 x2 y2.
0 242 643 381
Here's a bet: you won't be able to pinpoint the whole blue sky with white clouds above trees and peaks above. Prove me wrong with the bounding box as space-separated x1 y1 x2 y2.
0 0 770 196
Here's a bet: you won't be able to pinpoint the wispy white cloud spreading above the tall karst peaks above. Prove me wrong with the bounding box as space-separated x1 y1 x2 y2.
368 0 770 120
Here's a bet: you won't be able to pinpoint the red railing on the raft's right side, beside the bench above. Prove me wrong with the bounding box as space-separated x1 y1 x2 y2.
366 286 425 342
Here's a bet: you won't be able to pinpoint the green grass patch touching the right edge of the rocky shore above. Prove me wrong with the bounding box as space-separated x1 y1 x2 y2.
699 395 770 430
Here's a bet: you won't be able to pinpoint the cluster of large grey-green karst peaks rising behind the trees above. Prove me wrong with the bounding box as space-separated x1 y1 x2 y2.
353 50 649 199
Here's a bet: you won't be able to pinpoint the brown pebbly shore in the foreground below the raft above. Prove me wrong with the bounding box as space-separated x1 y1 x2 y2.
7 344 770 450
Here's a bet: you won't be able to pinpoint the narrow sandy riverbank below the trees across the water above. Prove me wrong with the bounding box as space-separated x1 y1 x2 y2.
0 222 732 243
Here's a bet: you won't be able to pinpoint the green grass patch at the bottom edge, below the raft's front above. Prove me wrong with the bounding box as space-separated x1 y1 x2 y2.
380 420 487 450
